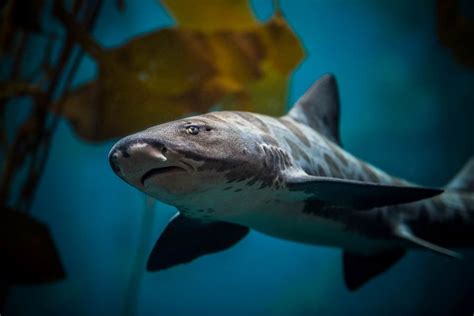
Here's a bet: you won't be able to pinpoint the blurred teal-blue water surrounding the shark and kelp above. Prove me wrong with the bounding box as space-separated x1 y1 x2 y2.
4 0 474 316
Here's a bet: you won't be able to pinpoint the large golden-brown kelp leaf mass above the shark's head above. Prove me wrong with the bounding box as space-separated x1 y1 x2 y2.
59 0 303 141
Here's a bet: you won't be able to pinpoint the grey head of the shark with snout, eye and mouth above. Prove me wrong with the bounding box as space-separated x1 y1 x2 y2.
109 112 268 202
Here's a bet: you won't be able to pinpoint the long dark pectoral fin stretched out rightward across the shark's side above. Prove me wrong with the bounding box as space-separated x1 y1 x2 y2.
286 175 443 210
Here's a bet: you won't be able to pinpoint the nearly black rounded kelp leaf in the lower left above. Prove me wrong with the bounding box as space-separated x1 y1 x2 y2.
0 209 65 284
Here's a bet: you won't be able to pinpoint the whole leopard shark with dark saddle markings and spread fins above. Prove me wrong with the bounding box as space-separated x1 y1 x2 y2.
109 74 474 290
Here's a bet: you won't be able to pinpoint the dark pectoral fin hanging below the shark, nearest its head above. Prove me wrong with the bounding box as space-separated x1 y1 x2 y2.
147 213 249 271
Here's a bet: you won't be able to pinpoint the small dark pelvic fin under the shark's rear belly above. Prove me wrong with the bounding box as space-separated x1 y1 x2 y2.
343 249 405 291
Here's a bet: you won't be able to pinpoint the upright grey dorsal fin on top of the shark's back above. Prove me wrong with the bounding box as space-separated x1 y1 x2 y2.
288 74 341 145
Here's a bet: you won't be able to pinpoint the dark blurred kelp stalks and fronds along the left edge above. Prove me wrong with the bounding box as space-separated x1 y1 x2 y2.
0 0 100 309
